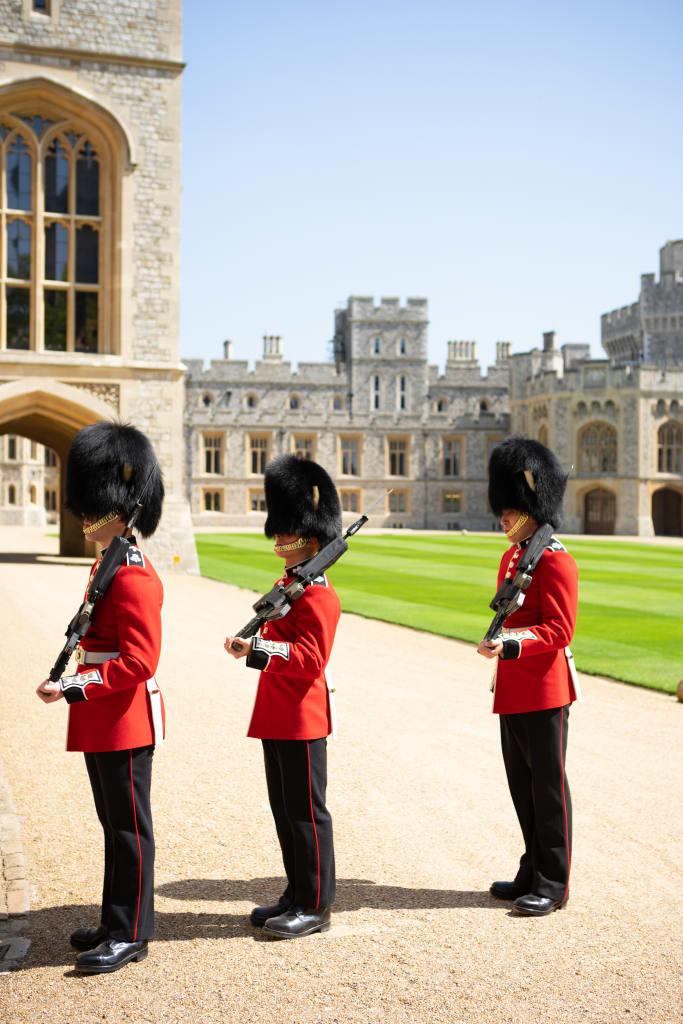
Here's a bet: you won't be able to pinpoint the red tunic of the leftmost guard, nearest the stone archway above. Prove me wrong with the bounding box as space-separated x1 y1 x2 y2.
67 548 164 752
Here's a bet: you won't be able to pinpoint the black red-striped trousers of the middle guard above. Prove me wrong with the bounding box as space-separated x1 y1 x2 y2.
262 738 335 910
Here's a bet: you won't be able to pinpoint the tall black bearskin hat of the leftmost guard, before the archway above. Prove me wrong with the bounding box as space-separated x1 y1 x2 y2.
67 420 164 537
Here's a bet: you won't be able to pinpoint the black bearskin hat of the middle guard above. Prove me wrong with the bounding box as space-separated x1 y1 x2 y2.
264 455 341 544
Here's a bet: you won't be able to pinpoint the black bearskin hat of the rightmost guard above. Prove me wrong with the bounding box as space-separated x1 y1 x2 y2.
488 437 567 528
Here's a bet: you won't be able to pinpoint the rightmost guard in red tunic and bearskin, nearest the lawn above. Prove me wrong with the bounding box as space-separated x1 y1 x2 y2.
477 437 580 916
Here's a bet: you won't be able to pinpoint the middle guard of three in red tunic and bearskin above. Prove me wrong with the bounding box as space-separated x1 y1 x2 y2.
225 455 341 939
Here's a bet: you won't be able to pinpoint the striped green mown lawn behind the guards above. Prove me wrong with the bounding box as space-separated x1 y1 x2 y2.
196 534 683 692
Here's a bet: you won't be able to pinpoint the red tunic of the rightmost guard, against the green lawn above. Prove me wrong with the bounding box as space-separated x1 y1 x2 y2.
494 538 579 715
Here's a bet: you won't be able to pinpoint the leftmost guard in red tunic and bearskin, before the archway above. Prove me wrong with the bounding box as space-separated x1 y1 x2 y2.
37 422 164 974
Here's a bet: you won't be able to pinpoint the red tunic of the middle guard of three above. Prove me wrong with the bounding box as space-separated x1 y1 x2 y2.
247 577 341 739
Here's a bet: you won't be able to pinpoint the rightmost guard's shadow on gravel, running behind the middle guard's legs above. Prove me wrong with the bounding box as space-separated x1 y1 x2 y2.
157 878 501 911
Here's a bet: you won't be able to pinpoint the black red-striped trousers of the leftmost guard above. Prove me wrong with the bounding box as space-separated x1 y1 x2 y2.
85 745 155 942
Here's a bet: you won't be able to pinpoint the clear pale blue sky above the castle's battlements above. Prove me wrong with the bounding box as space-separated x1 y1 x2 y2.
181 0 683 366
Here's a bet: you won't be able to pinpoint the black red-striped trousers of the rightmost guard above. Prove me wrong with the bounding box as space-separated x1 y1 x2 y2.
501 705 571 900
